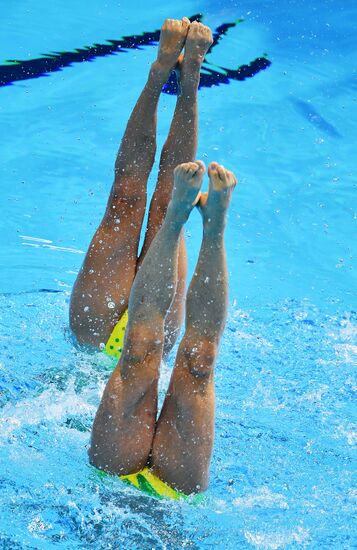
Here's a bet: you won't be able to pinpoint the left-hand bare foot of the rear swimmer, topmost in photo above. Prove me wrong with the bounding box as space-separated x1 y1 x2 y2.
157 17 190 74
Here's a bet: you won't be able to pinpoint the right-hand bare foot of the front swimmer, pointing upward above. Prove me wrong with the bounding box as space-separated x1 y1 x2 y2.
198 162 237 230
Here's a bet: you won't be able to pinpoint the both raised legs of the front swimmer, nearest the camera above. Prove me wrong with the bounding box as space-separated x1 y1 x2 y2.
90 161 236 494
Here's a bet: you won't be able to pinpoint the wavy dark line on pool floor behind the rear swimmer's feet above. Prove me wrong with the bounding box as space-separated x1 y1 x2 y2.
0 14 271 94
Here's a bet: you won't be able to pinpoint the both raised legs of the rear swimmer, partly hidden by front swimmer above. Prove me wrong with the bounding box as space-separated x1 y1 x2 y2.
70 18 212 352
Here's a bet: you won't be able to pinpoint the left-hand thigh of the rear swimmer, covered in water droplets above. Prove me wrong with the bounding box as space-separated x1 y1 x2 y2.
70 179 146 346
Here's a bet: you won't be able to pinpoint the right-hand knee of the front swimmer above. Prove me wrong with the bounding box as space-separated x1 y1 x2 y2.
183 339 218 378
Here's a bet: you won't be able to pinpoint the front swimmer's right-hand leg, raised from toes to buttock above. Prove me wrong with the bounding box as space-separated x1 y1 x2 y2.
151 163 236 494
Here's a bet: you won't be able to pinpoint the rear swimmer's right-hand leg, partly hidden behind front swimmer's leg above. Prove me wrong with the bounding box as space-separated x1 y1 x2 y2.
139 22 212 355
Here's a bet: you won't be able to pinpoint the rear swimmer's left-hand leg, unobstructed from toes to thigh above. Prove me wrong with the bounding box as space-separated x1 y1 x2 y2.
70 19 189 346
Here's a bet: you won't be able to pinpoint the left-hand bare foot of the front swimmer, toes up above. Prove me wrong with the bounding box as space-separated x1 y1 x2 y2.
170 160 206 222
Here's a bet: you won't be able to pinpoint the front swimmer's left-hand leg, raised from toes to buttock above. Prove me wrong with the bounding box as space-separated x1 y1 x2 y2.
89 162 205 474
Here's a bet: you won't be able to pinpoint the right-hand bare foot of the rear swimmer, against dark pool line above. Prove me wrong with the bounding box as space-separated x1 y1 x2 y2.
178 21 213 89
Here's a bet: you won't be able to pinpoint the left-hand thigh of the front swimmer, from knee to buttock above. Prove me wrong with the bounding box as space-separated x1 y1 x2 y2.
89 325 162 475
